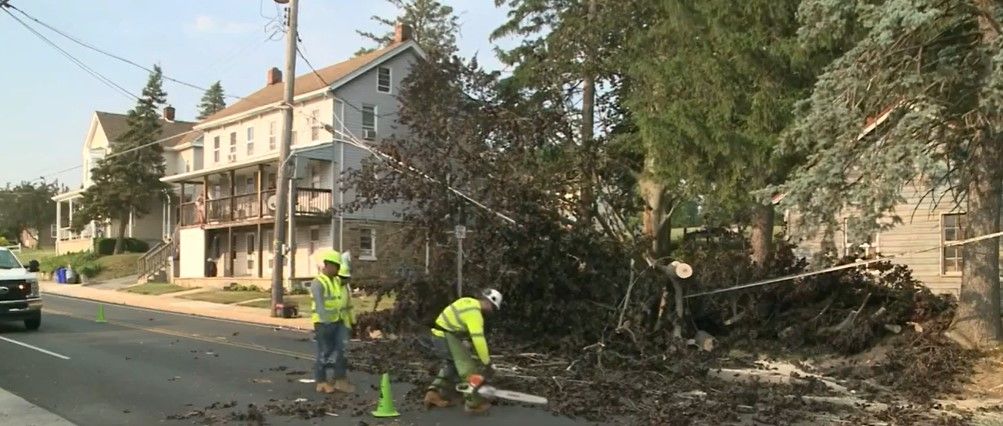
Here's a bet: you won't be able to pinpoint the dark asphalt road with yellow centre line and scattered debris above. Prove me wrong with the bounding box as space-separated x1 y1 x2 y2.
0 295 580 425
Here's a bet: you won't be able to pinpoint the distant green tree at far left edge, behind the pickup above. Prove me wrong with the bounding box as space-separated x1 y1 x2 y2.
0 181 60 241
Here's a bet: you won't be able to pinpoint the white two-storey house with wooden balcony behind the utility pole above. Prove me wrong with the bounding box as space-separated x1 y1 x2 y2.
163 26 425 287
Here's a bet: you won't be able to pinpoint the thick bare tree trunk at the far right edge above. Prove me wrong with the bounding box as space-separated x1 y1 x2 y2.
951 0 1003 348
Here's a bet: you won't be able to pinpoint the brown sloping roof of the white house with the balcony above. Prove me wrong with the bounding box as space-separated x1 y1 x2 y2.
202 41 417 123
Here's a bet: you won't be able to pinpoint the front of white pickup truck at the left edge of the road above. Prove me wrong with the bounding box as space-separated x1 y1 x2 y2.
0 247 42 330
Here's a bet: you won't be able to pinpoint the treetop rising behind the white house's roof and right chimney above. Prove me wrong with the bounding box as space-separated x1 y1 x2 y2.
356 0 459 60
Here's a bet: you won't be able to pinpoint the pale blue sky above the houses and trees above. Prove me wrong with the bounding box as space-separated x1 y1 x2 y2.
0 0 515 187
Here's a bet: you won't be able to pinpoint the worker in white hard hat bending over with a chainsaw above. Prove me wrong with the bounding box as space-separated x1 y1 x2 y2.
424 289 502 413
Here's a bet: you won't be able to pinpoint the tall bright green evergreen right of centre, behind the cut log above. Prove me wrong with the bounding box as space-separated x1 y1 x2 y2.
626 0 834 267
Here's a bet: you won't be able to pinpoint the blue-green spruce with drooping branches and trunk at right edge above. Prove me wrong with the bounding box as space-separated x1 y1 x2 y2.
780 0 1003 346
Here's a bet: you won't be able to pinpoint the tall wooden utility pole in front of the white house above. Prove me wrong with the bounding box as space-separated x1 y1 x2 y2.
272 0 300 316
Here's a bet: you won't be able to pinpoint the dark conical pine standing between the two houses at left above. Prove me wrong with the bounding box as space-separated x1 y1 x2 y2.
73 65 169 254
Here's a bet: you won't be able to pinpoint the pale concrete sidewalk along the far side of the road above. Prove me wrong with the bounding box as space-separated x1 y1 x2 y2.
39 282 313 330
